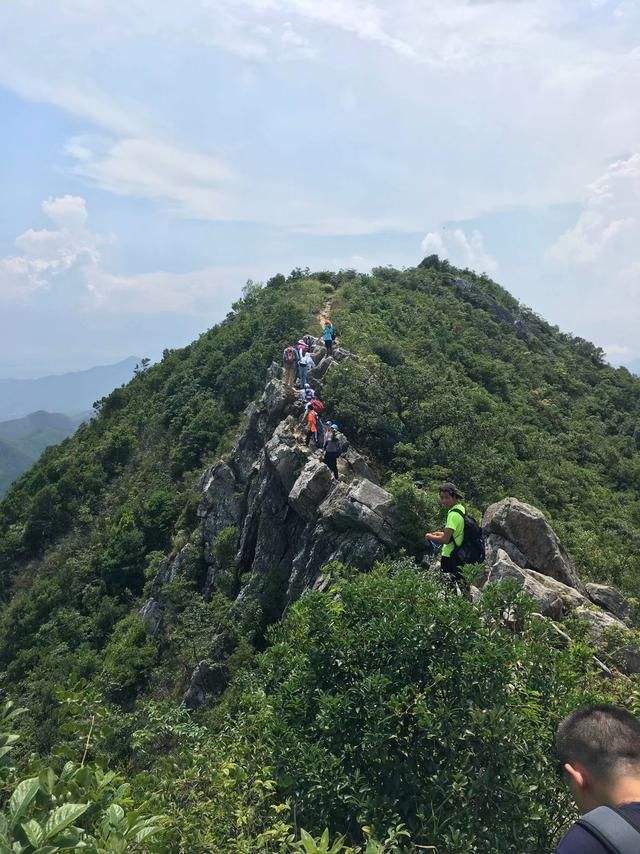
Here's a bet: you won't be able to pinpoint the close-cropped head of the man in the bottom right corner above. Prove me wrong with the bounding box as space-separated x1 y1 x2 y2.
556 706 640 812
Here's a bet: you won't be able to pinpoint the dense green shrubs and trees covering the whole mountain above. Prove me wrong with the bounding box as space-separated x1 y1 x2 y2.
0 258 640 852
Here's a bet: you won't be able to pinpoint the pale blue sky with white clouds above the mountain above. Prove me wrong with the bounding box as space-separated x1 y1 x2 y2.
0 0 640 377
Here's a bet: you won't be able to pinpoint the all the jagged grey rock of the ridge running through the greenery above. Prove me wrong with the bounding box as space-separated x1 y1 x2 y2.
140 339 640 708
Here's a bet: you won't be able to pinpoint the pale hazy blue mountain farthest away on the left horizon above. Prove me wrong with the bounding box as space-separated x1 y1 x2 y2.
0 356 139 421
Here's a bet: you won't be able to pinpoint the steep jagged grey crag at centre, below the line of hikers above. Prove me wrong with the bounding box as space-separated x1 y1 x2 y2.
198 342 401 636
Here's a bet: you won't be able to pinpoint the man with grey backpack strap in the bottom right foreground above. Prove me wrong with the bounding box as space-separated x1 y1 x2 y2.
556 705 640 854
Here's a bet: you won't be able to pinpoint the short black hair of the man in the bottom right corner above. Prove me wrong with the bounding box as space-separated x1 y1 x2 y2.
556 705 640 779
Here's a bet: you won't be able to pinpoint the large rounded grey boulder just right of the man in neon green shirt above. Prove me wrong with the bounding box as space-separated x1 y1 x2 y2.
482 498 586 595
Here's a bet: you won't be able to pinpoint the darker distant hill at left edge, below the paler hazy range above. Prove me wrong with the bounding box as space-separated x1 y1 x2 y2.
0 410 91 496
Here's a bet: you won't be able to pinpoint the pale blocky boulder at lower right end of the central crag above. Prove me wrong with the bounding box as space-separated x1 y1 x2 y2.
319 478 401 546
